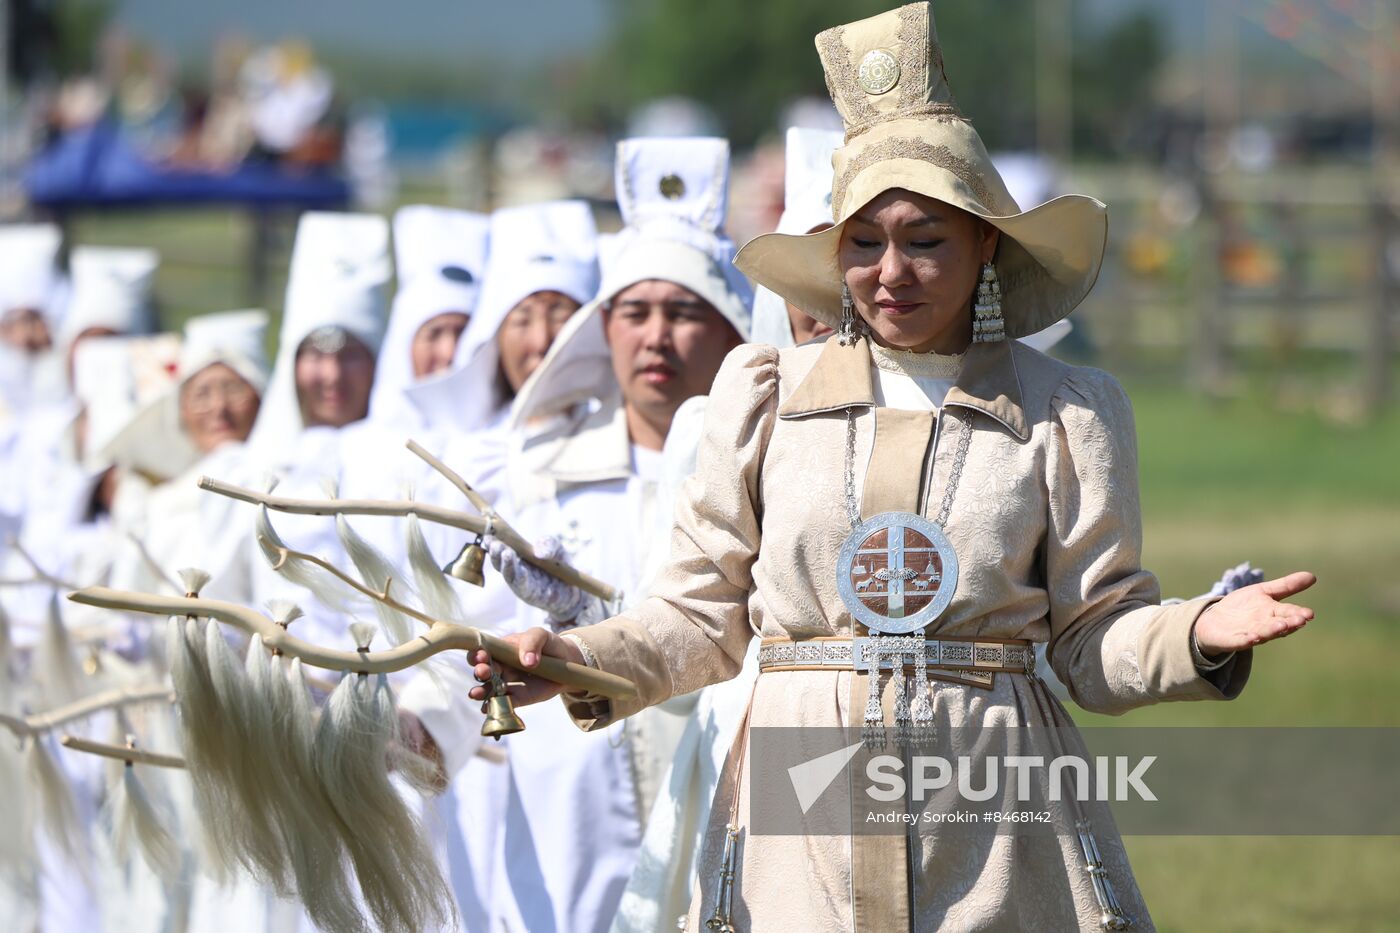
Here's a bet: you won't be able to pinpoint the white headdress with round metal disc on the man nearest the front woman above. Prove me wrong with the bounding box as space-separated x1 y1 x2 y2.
511 139 753 424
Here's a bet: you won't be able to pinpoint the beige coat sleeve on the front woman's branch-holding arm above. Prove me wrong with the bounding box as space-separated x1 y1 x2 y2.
566 345 777 730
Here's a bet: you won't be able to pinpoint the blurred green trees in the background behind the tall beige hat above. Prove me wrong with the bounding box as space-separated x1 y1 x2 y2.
563 0 1168 154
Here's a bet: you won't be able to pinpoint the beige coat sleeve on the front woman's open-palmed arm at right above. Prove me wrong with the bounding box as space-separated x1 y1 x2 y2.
1044 368 1252 714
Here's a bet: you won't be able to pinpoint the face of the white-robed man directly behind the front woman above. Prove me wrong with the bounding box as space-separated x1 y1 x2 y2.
603 279 741 426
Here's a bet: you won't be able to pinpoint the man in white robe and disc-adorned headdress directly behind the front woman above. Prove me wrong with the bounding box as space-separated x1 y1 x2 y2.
453 139 750 932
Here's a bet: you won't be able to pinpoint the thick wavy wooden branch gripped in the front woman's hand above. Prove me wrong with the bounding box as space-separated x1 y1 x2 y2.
69 587 637 699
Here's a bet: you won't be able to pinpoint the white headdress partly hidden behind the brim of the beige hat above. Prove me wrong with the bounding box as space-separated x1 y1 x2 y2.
753 126 846 347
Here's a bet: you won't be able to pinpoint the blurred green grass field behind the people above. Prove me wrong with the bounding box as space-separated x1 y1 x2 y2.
60 205 1400 932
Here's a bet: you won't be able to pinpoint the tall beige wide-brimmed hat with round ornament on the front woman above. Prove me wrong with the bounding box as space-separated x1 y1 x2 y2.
735 3 1107 338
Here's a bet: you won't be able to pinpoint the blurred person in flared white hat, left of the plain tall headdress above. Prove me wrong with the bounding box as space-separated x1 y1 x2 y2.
112 310 267 593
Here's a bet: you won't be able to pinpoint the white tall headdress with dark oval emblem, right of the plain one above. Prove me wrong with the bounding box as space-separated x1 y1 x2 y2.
370 205 490 422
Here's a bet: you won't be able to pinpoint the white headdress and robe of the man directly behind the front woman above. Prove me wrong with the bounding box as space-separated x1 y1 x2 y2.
493 139 750 930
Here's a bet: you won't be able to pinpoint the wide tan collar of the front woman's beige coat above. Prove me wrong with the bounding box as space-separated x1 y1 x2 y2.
778 338 1030 441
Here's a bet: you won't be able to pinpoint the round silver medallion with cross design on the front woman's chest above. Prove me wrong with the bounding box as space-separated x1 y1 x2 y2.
836 511 958 635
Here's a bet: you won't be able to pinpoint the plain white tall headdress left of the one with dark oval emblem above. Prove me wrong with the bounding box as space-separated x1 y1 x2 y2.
248 213 391 455
